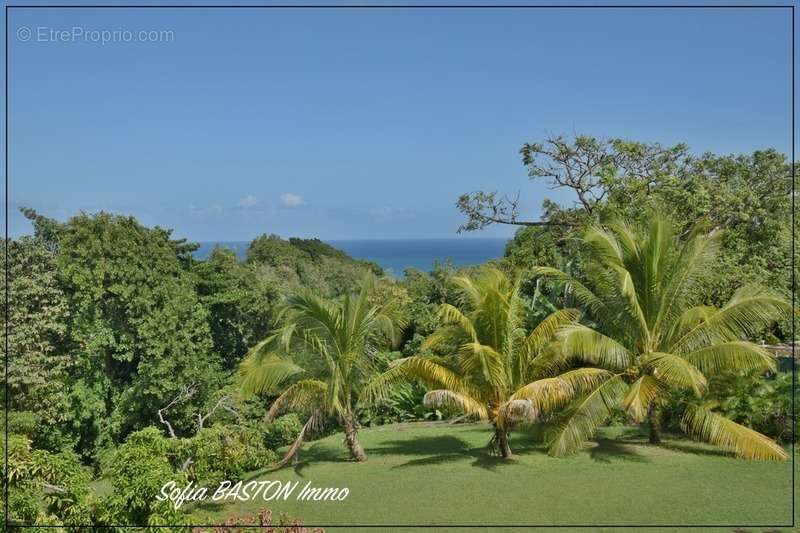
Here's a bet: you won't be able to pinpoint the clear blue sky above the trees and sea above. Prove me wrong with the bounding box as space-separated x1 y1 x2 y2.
9 5 791 241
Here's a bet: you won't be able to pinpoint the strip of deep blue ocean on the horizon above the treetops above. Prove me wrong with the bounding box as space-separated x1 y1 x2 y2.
195 238 508 277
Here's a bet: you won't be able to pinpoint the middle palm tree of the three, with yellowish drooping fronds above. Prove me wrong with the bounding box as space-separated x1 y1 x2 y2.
364 268 604 458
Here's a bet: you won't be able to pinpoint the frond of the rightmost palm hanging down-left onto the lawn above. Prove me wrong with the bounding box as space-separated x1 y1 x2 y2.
546 375 628 457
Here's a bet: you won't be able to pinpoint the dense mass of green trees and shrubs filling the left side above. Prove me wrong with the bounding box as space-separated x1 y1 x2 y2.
3 209 376 524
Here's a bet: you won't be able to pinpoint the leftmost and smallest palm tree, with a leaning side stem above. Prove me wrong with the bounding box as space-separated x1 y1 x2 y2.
239 279 403 463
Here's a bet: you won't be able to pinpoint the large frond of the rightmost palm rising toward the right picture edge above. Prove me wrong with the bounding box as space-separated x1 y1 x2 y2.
672 286 792 352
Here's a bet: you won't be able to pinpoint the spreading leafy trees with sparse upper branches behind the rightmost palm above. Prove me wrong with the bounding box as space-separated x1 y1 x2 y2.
490 136 792 320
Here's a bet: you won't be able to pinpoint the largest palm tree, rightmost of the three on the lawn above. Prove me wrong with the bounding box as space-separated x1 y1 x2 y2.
534 216 791 459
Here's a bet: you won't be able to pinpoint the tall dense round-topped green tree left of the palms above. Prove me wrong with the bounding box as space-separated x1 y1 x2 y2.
46 213 220 450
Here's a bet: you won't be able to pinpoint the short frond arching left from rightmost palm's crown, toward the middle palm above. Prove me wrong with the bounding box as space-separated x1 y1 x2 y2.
559 324 633 370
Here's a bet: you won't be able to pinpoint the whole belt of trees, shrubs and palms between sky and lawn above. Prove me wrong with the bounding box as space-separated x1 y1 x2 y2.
3 137 793 525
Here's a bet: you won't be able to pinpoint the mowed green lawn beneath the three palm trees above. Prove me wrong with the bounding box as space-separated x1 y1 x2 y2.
187 423 792 531
